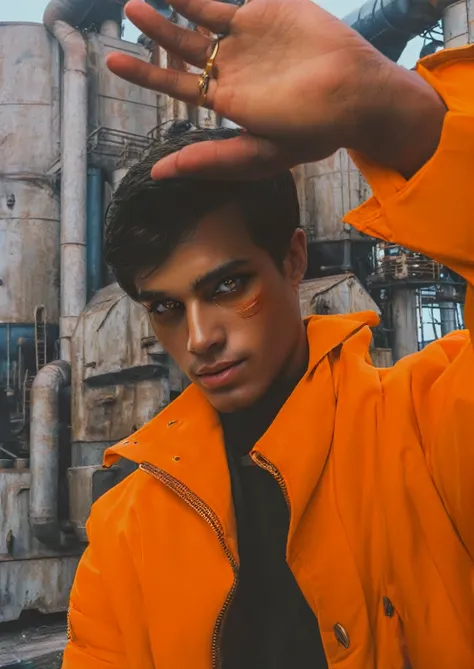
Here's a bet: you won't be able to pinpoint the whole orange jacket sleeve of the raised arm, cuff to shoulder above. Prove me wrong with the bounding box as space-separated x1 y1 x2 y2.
345 46 474 558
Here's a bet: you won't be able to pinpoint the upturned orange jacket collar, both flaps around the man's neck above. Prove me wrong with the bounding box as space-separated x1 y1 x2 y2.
104 312 378 534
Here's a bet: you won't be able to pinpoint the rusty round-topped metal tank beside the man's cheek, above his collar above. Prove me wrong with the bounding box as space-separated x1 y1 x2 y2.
72 284 169 448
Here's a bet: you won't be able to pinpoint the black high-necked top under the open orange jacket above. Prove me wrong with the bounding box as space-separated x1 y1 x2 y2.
220 360 327 669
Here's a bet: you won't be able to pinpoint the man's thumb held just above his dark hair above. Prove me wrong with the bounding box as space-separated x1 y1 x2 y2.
152 133 292 181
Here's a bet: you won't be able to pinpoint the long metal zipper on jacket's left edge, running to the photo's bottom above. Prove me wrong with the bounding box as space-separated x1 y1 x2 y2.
140 462 239 669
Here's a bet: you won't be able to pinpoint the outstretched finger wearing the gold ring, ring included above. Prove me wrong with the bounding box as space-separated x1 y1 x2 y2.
107 53 216 109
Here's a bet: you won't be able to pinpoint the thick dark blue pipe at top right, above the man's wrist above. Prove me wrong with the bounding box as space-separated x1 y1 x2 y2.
343 0 456 61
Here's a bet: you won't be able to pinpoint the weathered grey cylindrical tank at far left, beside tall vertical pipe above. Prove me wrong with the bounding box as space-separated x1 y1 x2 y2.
0 23 60 385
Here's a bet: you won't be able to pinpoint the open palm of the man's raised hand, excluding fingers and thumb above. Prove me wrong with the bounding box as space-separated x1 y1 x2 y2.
210 0 365 138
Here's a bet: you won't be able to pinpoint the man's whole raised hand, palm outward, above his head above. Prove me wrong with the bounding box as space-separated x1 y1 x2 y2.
107 0 444 178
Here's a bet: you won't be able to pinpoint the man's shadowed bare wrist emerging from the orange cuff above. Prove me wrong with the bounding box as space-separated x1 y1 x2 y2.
347 62 447 179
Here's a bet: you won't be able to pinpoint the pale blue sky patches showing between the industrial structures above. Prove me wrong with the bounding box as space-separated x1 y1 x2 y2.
0 0 422 67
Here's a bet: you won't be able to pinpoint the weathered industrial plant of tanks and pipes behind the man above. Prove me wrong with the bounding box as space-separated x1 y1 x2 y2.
0 0 468 667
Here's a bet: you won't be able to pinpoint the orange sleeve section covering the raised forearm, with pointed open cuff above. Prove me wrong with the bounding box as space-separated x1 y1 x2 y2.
345 46 474 331
